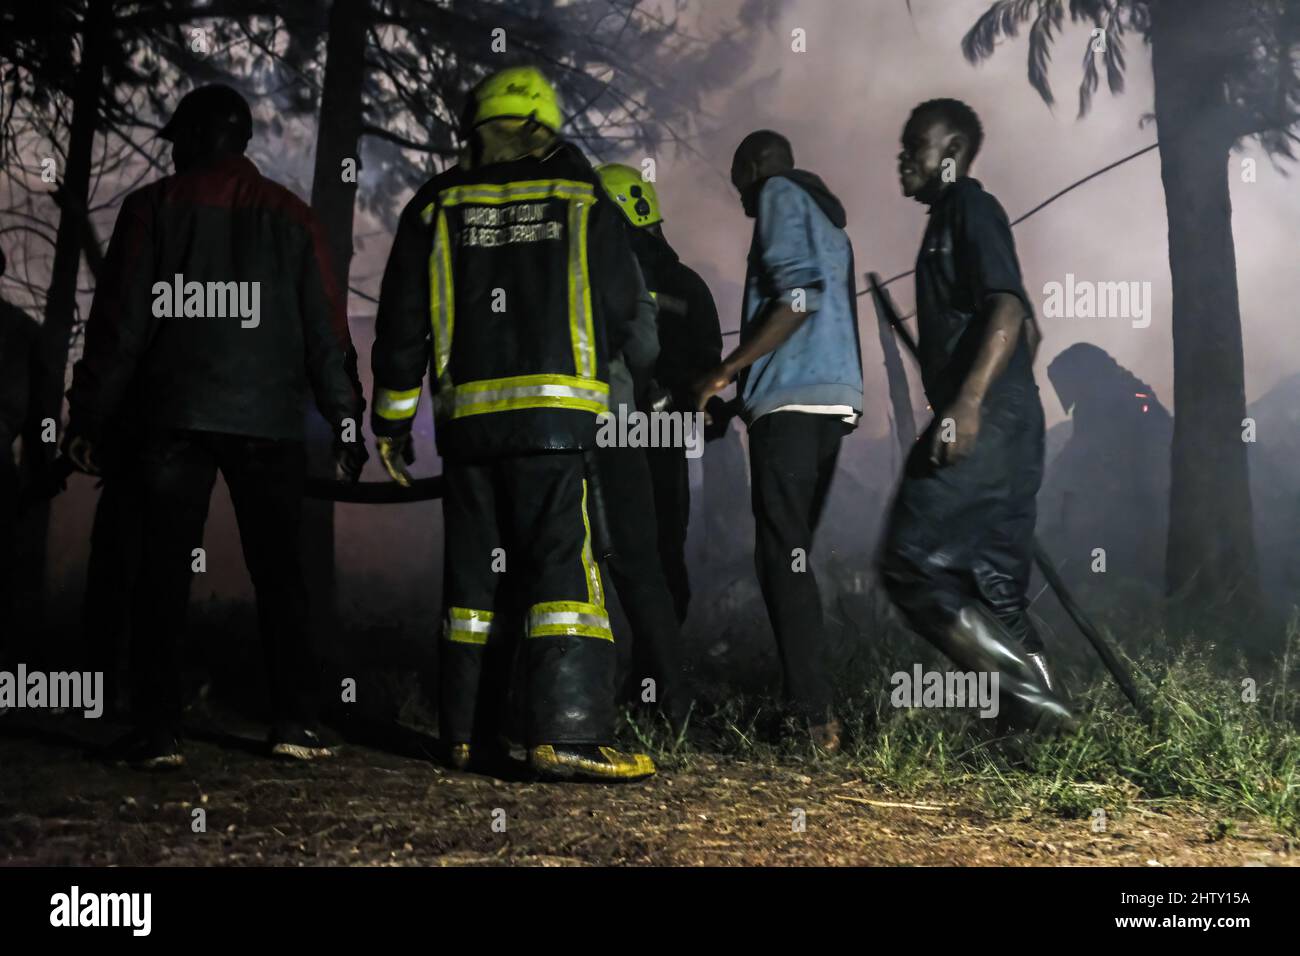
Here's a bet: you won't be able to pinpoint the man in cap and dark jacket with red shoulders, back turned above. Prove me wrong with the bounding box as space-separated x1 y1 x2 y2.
64 86 367 769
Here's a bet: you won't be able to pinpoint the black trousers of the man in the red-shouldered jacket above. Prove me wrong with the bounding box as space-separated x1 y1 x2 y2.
129 431 320 731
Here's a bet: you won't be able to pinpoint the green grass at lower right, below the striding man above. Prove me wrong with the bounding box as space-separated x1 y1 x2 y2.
625 619 1300 839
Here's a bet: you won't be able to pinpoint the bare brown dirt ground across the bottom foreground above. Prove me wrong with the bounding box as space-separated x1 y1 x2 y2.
0 718 1300 866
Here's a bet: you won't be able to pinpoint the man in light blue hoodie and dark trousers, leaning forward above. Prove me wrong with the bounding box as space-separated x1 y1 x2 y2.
696 130 862 753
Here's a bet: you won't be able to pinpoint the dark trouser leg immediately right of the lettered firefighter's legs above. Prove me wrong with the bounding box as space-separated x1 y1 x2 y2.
595 447 684 702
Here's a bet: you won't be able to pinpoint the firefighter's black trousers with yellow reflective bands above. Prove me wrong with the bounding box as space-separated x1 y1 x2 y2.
438 453 616 745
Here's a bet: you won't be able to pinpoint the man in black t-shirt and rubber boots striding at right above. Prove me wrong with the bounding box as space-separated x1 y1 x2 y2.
880 100 1074 728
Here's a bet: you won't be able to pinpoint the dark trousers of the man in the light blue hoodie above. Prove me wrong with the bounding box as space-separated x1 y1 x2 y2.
749 411 849 721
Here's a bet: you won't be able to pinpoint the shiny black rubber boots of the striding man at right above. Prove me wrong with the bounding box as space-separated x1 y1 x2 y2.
935 605 1078 734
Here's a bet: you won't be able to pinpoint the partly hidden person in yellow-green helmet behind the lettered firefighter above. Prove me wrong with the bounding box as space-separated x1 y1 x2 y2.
597 163 723 624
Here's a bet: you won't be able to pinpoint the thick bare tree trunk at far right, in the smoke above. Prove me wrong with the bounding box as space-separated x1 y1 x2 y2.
1152 0 1260 624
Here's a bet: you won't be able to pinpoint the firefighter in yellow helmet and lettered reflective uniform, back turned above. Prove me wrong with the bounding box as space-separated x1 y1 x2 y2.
372 66 654 780
